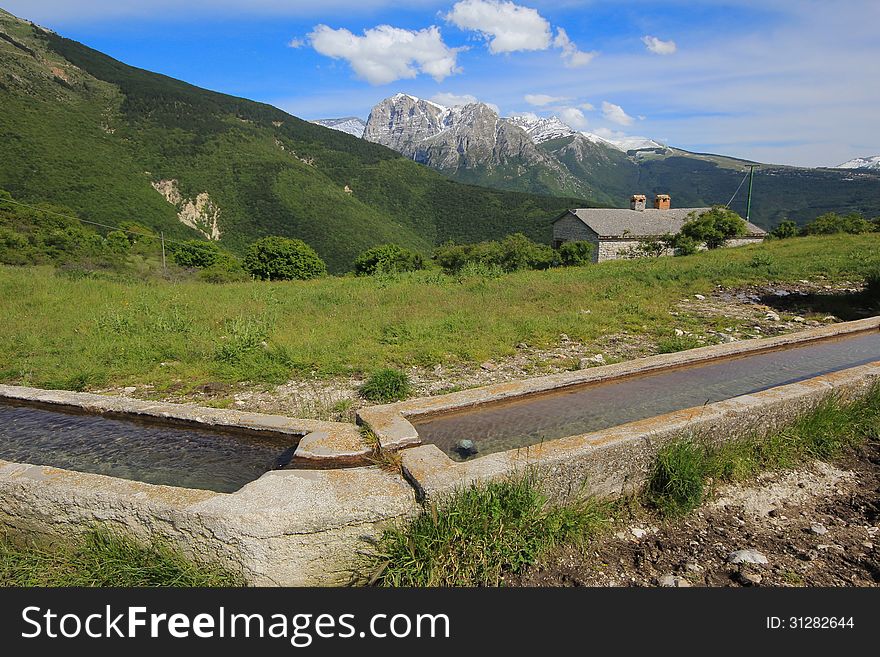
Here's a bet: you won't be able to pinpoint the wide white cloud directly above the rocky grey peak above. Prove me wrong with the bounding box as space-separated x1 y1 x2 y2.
309 25 461 84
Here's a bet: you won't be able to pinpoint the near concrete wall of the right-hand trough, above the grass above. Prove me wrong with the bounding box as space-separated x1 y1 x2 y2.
401 361 880 500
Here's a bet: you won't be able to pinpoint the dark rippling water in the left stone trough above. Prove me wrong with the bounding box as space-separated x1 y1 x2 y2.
0 401 299 493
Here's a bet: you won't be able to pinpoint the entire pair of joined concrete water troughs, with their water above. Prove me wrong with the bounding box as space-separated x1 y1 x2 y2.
0 318 880 585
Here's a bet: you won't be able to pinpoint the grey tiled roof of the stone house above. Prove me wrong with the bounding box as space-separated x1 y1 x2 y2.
560 208 765 238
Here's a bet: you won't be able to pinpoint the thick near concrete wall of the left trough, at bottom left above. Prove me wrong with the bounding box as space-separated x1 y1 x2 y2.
0 461 421 586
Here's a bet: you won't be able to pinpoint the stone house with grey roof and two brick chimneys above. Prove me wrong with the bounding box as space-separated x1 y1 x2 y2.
553 194 767 262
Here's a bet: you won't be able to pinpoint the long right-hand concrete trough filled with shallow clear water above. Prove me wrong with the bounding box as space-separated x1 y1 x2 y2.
359 317 880 498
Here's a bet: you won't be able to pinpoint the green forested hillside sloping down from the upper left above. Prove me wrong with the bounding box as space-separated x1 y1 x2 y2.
0 10 583 272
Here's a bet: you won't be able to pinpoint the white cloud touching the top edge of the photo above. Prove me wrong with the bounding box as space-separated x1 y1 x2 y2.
446 0 551 54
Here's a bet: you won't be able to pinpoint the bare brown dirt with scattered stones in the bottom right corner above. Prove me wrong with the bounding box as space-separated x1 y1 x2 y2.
509 440 880 587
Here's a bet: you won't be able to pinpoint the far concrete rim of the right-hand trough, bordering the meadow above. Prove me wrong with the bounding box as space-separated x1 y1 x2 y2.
358 316 880 448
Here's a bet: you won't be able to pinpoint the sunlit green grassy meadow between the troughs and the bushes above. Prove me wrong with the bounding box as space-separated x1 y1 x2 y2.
0 233 880 391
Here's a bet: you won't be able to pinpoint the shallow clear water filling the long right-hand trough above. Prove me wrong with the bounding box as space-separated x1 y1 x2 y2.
410 331 880 461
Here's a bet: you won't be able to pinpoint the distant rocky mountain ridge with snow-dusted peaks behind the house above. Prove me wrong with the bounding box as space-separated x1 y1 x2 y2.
312 93 880 228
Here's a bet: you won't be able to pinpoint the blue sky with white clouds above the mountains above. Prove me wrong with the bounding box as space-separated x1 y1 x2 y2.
8 0 880 166
